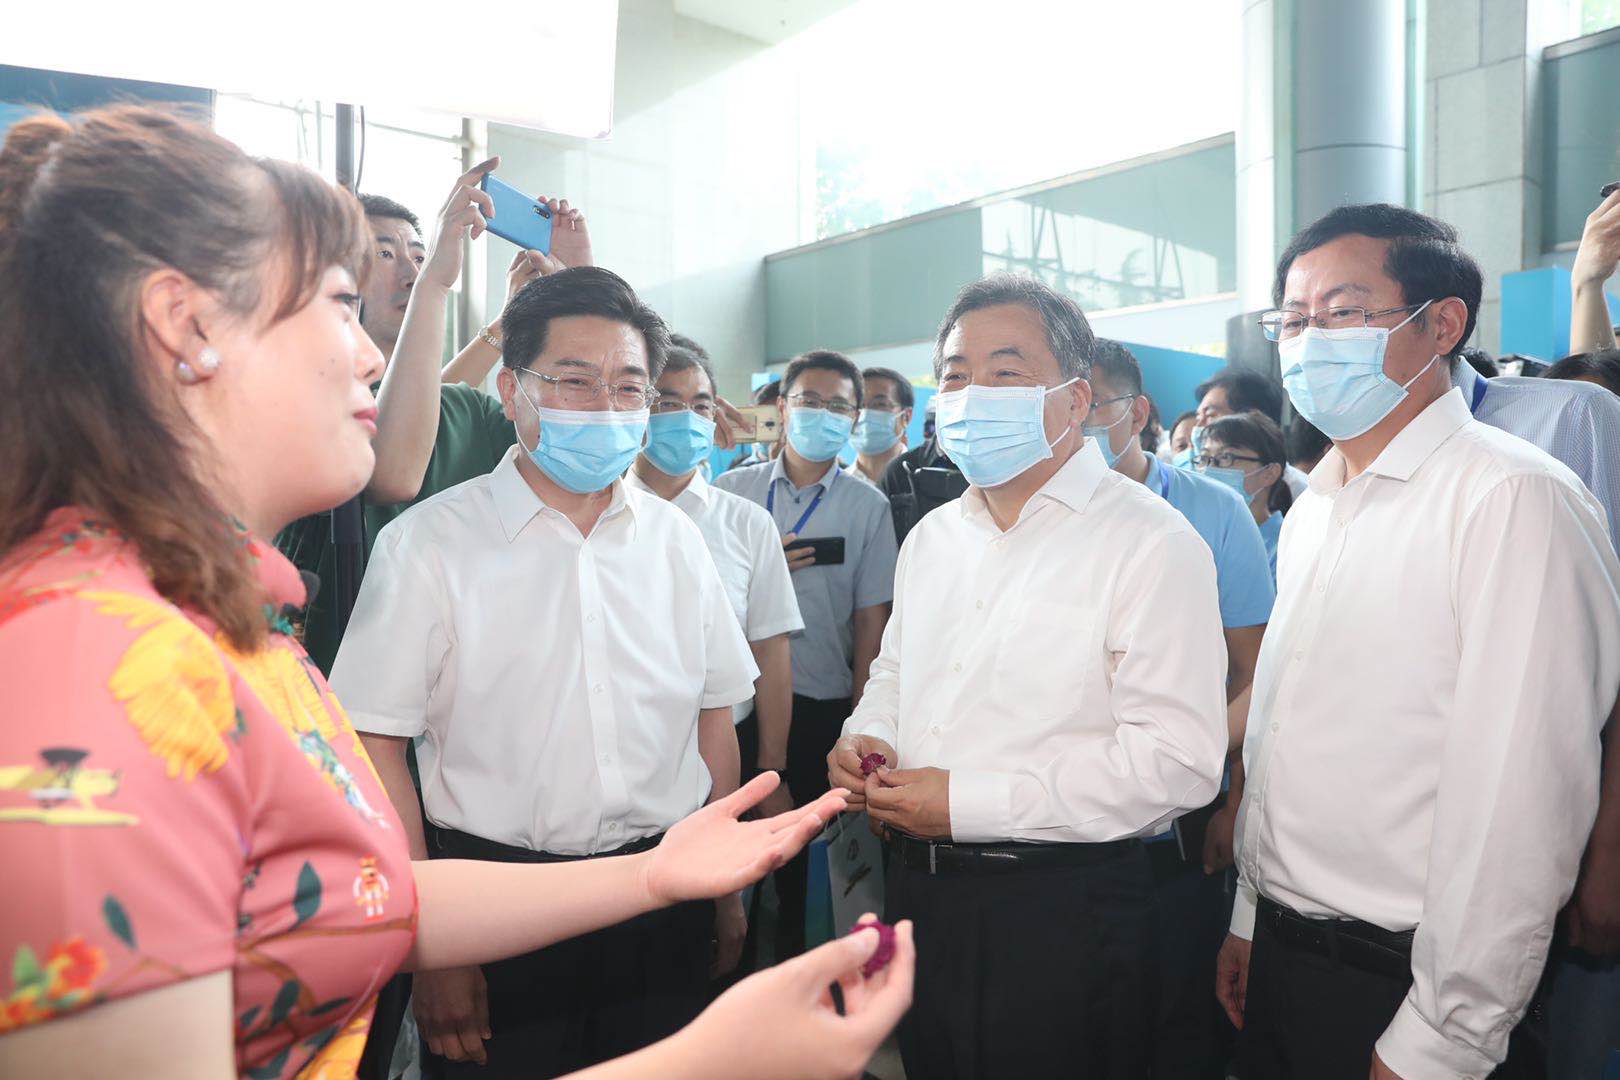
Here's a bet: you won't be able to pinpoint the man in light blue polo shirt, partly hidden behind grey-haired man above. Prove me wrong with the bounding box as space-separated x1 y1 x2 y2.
1085 338 1277 1080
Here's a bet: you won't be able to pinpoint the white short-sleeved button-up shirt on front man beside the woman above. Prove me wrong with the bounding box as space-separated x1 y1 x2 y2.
332 449 758 855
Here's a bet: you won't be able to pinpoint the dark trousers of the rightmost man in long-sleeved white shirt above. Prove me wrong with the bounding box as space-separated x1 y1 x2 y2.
1238 893 1542 1080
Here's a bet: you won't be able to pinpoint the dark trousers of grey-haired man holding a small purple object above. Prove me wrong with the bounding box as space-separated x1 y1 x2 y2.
886 847 1166 1080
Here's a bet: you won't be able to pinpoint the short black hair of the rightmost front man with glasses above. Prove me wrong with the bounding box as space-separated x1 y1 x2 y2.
1272 202 1484 355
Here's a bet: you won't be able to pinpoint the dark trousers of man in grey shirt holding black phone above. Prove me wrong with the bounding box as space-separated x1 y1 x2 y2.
737 693 851 960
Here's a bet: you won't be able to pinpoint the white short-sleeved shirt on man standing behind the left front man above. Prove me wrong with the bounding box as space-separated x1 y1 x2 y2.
624 468 805 724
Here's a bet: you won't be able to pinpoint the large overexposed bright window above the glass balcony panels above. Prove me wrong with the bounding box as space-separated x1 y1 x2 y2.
792 0 1241 240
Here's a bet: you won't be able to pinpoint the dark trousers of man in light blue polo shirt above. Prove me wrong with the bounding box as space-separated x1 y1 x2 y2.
1147 840 1231 1080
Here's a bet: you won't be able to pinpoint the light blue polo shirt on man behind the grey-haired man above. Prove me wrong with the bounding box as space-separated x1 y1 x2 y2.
1147 453 1281 627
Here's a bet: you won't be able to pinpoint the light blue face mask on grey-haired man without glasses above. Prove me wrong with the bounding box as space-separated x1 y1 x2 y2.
935 379 1079 487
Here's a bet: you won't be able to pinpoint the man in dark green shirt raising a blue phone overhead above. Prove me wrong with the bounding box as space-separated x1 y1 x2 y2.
275 159 591 674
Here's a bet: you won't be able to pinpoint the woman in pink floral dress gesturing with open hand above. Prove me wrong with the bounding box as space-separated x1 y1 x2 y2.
0 107 914 1080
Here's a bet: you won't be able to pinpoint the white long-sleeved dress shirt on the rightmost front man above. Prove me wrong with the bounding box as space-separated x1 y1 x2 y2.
1233 390 1620 1080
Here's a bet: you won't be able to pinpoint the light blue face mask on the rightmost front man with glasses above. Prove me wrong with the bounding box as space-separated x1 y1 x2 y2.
1277 301 1440 440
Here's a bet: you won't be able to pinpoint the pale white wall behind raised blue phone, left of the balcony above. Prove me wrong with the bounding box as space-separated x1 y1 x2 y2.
484 0 812 397
